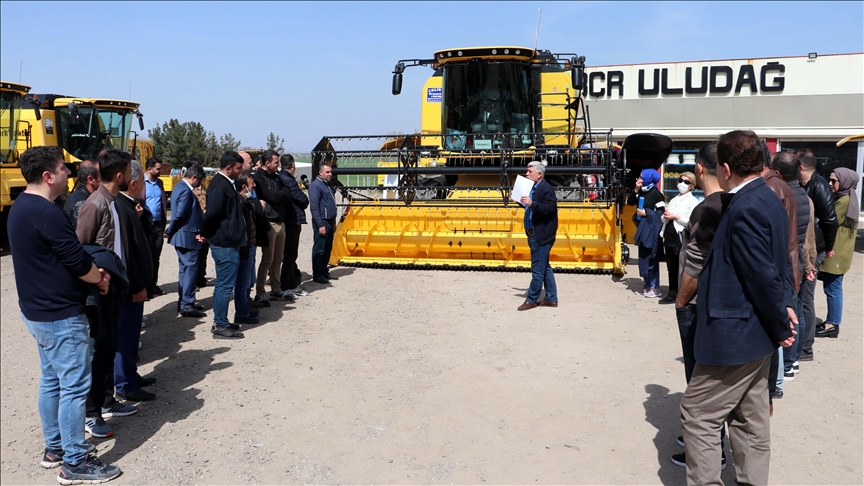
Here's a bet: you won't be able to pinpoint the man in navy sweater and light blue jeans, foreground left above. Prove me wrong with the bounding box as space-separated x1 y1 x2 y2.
7 146 120 484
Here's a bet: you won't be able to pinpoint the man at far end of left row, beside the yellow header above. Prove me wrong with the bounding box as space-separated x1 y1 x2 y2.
309 163 338 285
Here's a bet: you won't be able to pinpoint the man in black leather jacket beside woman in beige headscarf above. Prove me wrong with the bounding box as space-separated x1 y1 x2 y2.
795 149 840 361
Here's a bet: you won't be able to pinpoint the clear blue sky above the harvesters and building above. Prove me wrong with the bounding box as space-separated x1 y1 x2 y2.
0 1 864 152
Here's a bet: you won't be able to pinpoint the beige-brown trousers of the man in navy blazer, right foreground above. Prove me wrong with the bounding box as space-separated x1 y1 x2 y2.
681 356 771 486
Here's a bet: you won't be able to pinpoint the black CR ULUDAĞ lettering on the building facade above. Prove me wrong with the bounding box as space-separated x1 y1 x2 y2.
584 62 786 98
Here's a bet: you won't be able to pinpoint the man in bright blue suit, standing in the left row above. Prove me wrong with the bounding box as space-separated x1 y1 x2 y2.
165 165 207 317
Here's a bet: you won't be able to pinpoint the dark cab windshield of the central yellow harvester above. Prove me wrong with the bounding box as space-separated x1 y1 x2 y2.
443 59 534 150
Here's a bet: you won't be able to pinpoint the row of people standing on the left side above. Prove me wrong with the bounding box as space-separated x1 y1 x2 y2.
8 147 337 484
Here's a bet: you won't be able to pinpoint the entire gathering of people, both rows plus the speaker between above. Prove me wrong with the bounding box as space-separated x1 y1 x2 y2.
8 131 859 484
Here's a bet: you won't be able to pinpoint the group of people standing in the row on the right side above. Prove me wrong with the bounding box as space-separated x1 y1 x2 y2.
628 131 859 484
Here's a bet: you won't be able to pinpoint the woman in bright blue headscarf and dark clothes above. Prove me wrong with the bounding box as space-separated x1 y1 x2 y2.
627 169 666 298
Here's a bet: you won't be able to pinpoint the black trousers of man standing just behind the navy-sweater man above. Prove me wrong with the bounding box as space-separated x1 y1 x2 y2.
86 296 120 418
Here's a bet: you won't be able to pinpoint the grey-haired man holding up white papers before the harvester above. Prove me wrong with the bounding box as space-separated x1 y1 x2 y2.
518 162 558 310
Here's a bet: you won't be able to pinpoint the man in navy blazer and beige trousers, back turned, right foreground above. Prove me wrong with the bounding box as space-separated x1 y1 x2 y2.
681 131 797 485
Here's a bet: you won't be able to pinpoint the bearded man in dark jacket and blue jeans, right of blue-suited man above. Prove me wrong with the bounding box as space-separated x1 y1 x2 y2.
199 151 246 339
